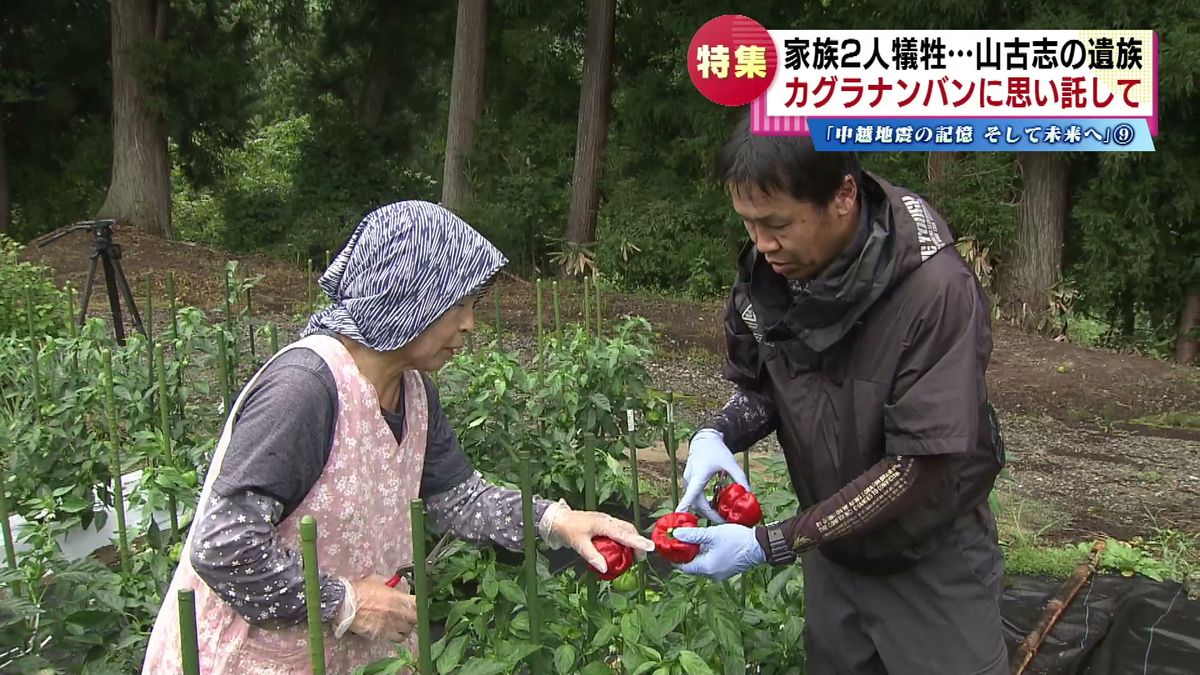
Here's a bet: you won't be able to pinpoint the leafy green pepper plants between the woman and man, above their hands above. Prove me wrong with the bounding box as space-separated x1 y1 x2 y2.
438 319 661 504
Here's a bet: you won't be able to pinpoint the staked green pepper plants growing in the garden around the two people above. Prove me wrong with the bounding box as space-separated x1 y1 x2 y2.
0 247 803 674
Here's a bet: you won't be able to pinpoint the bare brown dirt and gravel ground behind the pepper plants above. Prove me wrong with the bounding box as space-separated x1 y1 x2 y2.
26 223 1200 539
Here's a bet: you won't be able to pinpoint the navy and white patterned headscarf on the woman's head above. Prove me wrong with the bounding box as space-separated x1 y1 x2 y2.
304 201 509 352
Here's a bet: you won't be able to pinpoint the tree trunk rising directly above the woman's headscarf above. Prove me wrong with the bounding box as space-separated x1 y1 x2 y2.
442 0 488 211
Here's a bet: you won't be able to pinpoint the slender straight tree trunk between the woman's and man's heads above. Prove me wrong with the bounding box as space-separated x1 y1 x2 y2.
566 0 617 276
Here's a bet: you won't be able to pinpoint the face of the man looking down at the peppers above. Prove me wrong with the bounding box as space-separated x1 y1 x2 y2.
730 177 859 279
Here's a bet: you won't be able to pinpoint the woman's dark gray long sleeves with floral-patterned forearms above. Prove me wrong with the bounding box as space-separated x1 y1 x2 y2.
191 341 551 623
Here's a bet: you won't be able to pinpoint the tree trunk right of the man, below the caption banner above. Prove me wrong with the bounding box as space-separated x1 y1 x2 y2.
998 153 1068 313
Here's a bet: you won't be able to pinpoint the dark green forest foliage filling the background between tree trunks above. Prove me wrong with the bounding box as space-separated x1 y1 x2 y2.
9 0 1200 356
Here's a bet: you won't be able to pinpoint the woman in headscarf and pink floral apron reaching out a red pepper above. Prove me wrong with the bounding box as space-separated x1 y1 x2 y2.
143 202 654 674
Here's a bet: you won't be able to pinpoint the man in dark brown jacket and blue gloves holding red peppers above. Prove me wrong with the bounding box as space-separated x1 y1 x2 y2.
676 112 1007 675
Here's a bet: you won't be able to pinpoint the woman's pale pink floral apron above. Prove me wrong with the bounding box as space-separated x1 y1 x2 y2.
142 335 428 675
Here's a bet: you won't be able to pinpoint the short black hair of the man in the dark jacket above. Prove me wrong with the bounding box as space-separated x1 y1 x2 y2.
716 109 862 207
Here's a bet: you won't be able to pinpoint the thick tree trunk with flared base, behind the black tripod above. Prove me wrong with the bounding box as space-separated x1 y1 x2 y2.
100 0 172 239
